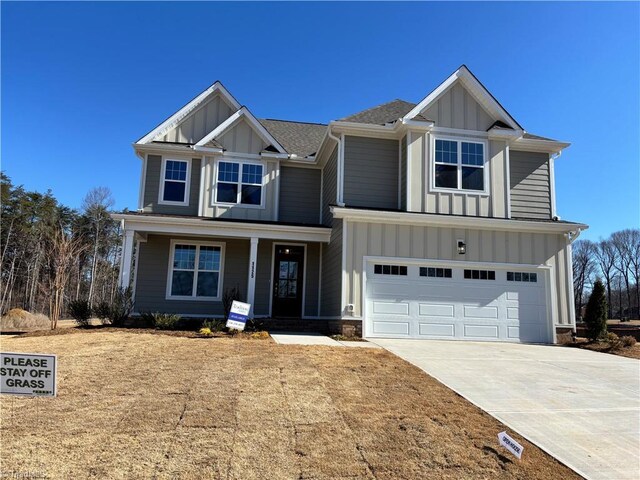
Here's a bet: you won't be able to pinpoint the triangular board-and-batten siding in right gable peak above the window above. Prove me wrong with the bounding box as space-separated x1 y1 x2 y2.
421 81 494 132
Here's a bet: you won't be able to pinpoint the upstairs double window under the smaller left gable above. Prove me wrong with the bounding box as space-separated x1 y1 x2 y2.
216 162 263 206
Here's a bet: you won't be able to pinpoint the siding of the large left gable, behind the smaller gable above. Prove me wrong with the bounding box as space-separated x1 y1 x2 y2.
154 95 234 143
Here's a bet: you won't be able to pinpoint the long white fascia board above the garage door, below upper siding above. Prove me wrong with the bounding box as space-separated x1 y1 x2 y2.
331 207 589 234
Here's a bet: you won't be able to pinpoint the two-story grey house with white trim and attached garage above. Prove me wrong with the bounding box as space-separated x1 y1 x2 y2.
115 66 587 342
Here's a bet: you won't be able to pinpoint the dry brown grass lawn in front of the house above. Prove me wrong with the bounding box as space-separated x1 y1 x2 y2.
0 331 579 480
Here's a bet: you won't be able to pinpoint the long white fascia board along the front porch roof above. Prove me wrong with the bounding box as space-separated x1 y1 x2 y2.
111 213 331 243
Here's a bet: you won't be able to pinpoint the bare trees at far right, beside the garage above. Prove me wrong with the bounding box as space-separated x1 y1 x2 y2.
573 228 640 319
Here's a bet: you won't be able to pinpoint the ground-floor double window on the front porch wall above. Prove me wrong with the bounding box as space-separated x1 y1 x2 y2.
167 241 222 300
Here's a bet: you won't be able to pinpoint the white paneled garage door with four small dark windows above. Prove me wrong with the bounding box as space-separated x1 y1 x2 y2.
365 262 552 343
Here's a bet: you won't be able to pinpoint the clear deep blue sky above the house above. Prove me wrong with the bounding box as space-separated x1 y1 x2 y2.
0 2 640 239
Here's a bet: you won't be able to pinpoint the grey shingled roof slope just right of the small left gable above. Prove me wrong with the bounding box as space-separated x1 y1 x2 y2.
260 118 327 157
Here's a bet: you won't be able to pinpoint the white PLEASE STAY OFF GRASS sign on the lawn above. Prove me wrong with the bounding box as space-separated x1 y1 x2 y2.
0 352 57 397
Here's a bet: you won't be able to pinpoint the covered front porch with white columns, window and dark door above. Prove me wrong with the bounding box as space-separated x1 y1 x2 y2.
115 214 331 318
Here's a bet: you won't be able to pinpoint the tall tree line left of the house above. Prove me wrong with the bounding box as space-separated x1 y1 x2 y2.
0 173 120 328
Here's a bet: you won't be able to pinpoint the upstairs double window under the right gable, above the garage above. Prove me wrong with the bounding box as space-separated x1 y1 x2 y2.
433 138 485 192
